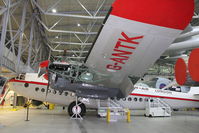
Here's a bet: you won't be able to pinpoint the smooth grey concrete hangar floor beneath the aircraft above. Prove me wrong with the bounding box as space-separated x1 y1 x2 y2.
0 109 199 133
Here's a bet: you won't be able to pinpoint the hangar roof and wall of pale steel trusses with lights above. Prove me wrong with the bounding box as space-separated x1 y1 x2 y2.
0 0 199 73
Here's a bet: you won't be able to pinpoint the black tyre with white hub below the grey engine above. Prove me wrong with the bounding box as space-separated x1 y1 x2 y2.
68 101 86 117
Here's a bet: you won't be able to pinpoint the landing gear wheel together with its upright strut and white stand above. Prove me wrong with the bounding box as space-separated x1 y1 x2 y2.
68 97 86 119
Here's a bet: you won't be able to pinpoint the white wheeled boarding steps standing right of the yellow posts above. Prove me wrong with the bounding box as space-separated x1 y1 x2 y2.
145 98 172 117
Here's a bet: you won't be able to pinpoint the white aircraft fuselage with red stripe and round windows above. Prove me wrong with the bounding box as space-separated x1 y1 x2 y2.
7 73 199 116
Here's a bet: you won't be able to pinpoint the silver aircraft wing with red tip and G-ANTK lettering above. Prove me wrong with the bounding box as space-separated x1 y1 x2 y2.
85 0 194 95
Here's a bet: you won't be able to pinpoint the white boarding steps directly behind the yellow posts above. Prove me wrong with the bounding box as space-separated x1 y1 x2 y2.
97 99 128 122
